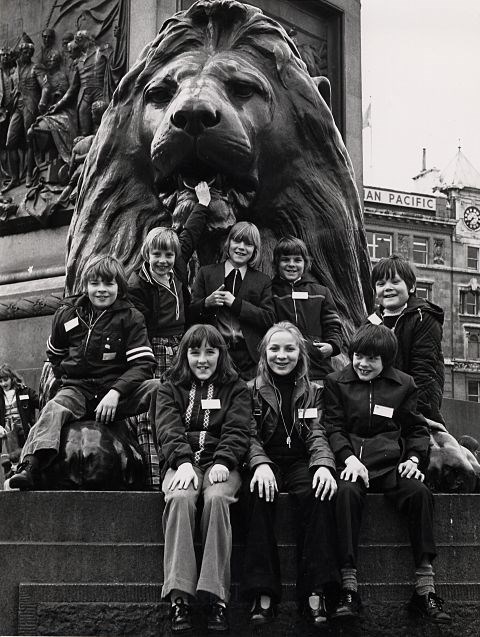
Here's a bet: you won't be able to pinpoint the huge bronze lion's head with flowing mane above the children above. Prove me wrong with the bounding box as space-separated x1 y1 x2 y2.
67 0 371 336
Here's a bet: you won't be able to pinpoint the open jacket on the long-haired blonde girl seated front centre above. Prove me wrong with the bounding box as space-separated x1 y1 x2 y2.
247 376 335 472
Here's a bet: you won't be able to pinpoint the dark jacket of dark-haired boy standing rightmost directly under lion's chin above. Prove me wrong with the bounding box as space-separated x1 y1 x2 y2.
272 273 342 379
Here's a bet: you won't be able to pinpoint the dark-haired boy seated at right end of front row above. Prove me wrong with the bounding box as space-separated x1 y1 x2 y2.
324 324 450 624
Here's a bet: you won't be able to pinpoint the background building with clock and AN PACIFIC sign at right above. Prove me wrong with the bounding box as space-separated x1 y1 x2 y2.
364 148 480 410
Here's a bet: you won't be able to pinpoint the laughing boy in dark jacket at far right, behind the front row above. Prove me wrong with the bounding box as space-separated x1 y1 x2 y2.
369 255 445 424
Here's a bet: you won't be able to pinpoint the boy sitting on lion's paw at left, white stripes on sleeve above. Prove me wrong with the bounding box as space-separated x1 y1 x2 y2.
10 256 157 489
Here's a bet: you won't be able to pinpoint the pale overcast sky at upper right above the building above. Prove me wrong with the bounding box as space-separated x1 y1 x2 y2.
362 0 480 190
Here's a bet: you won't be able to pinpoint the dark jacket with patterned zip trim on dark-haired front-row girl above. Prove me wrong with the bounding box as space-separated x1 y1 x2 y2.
155 379 252 472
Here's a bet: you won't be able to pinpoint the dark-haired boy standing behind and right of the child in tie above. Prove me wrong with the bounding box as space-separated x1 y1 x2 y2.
272 237 342 380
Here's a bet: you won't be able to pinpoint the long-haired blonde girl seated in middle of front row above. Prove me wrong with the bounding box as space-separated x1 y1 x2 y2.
242 321 338 625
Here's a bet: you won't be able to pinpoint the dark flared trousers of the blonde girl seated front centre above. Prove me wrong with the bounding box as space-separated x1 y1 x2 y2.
242 460 338 604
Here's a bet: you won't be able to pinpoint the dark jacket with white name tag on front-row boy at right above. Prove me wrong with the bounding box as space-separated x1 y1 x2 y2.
323 364 430 470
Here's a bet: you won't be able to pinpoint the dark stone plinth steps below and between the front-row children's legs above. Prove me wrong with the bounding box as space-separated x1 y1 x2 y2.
0 492 480 637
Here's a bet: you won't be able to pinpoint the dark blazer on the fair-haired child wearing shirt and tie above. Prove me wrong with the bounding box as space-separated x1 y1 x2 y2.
190 262 275 363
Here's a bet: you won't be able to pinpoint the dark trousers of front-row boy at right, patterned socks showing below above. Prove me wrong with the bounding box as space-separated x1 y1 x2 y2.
336 476 436 568
